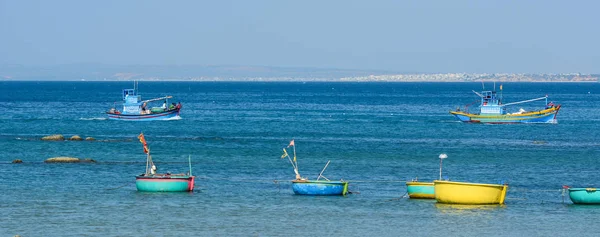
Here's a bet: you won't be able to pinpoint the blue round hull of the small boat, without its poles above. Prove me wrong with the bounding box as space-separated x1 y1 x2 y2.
292 180 348 196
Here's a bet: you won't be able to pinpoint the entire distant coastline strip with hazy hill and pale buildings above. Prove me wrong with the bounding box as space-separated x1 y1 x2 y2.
0 64 600 82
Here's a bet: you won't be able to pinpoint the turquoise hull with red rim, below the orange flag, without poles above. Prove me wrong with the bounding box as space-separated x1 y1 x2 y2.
135 175 195 192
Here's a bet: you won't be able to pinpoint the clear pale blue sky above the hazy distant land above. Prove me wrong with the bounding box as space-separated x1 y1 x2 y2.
0 0 600 73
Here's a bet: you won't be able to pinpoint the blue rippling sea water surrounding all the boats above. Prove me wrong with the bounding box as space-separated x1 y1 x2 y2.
0 81 600 236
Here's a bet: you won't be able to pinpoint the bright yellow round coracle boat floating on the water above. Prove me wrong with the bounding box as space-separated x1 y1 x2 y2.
433 180 508 205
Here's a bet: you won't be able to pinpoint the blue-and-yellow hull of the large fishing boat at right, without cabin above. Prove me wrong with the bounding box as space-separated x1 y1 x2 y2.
450 105 560 123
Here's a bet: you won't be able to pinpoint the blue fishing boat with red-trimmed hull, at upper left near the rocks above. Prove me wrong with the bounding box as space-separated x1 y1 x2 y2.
106 82 181 121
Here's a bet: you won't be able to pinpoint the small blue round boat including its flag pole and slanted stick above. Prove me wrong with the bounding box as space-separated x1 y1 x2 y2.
281 140 348 196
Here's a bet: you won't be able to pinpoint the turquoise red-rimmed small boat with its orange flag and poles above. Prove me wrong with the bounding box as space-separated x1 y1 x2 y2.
135 133 195 192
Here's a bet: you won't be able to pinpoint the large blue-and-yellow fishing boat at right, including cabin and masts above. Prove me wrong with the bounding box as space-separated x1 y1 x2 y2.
450 85 560 123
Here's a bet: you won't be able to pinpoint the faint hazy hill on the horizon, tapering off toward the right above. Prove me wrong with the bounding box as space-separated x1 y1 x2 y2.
0 64 399 81
